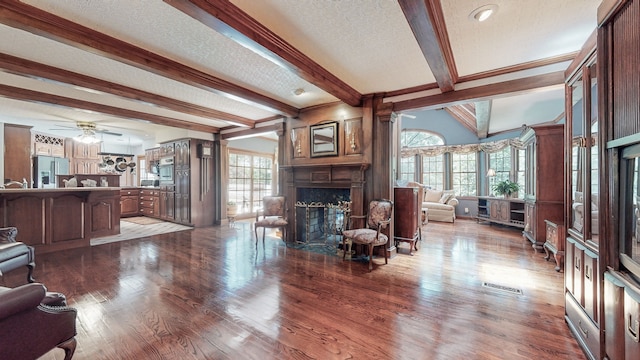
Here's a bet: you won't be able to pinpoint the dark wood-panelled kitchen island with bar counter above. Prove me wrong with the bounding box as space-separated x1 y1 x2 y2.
0 187 120 253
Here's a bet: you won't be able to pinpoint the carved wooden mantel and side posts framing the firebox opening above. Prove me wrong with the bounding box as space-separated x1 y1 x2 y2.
281 163 369 241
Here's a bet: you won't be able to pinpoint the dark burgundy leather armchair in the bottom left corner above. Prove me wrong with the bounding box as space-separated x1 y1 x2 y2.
0 283 77 360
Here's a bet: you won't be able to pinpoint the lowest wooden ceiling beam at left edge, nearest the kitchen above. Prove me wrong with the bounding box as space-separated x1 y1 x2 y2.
0 84 220 134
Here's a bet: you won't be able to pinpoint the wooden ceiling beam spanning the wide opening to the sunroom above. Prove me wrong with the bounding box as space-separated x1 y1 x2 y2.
393 71 564 111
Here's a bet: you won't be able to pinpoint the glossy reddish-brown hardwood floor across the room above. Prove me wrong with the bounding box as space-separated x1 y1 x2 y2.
2 220 584 360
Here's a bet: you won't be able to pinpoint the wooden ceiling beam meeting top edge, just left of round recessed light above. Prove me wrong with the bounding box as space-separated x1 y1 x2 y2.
398 0 458 93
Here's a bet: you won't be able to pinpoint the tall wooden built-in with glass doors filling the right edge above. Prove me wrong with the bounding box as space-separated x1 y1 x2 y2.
564 0 640 360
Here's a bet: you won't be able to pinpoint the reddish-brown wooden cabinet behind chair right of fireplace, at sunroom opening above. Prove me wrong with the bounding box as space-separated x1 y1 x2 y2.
393 187 422 254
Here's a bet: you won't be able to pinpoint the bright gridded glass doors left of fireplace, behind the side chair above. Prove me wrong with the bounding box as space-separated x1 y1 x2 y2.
228 151 273 214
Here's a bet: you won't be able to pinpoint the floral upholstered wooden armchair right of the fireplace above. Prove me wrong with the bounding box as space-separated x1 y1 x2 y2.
342 199 393 271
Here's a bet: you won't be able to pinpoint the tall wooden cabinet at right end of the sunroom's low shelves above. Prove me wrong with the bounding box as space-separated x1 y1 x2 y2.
520 124 564 251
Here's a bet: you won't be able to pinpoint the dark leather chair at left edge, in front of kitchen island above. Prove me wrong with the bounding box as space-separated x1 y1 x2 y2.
0 227 36 283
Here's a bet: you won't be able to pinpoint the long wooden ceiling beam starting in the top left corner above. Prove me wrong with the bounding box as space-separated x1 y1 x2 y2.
0 0 298 116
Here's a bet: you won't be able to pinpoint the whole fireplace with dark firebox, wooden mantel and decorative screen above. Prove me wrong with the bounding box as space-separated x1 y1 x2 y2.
282 163 369 242
